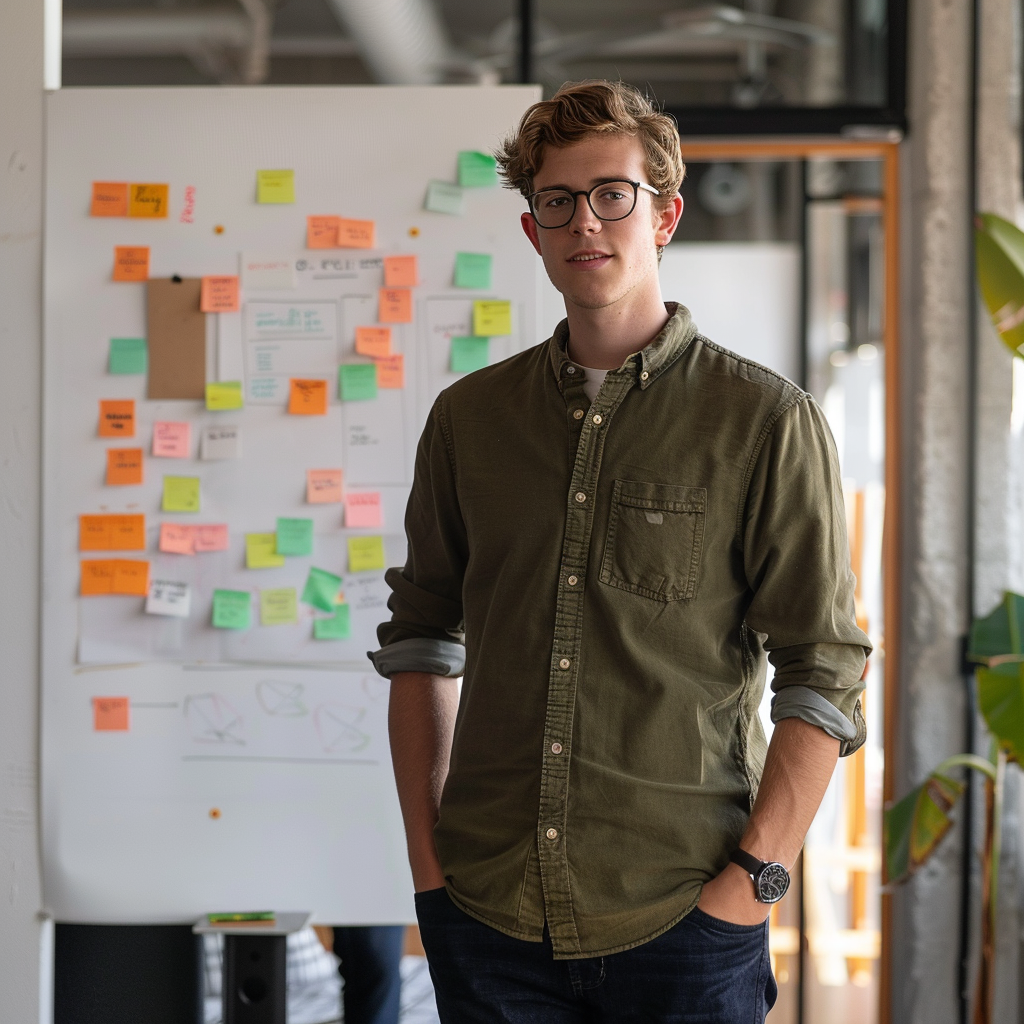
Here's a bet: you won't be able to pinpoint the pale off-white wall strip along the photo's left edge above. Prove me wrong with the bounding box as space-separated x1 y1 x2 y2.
0 0 43 1024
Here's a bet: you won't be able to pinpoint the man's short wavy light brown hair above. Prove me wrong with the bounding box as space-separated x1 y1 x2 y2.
495 79 686 205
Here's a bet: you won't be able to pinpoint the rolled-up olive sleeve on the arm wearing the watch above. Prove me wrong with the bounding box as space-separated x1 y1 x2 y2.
741 397 871 756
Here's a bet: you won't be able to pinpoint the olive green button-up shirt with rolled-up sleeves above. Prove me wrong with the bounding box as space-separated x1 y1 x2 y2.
372 306 869 958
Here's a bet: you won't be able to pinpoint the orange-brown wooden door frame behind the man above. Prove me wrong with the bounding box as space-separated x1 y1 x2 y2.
681 137 901 1024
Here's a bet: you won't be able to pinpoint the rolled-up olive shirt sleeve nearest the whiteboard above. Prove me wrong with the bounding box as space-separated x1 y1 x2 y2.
369 392 467 676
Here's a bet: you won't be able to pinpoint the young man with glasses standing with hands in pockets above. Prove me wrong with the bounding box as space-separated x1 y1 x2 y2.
372 82 869 1024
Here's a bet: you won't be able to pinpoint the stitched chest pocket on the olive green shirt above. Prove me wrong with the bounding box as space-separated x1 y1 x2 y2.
600 480 708 601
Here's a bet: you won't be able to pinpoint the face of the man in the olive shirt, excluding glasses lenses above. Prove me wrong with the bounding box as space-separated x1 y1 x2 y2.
522 135 682 309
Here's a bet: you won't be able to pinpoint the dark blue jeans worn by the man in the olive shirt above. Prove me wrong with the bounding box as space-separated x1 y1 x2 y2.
416 889 777 1024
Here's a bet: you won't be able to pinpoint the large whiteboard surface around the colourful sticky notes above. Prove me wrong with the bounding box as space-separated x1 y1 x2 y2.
42 87 551 924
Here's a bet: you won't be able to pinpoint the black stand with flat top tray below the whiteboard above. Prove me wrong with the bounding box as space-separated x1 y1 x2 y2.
193 910 312 1024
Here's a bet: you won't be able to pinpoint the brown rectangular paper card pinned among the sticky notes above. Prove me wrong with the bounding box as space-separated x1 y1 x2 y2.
146 278 206 401
